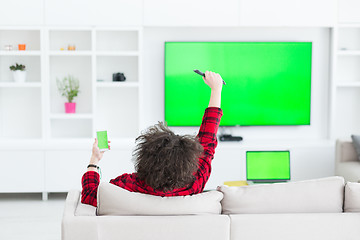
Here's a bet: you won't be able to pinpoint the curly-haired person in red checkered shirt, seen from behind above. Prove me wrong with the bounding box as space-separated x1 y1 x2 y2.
81 71 223 207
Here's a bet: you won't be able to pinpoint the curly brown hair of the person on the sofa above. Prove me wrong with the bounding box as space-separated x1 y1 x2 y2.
133 122 203 192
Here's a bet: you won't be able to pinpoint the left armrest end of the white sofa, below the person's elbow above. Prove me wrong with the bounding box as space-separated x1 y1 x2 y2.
61 190 98 240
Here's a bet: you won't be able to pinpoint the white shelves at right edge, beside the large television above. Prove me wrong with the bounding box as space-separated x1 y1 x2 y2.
330 24 360 139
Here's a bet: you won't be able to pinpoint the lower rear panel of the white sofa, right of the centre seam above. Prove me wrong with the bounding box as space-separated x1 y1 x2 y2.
230 213 360 240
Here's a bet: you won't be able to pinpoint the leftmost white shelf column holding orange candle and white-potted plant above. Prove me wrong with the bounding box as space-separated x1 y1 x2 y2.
0 28 43 141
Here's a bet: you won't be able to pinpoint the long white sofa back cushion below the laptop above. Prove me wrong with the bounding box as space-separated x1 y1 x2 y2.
218 177 344 214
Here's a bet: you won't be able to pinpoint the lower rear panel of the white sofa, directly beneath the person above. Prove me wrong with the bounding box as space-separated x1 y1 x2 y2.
97 214 229 240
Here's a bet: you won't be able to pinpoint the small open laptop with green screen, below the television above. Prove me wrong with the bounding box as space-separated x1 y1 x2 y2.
246 151 290 182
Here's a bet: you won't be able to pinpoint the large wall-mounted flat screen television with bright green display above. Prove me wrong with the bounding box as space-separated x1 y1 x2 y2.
164 42 312 126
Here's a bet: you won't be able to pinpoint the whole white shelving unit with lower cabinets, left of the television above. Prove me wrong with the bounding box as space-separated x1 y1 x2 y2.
0 26 142 199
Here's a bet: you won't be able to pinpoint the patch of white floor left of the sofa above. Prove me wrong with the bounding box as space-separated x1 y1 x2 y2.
0 193 66 240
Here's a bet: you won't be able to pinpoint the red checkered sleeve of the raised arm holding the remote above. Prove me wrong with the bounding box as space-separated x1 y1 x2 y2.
192 107 222 193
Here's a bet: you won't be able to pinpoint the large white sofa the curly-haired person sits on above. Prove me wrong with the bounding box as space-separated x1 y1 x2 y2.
62 177 360 240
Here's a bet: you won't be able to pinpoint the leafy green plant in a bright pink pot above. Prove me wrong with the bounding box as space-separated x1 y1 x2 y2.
56 75 79 113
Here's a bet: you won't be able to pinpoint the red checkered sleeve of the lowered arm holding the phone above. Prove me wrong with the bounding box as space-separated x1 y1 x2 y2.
81 171 100 207
